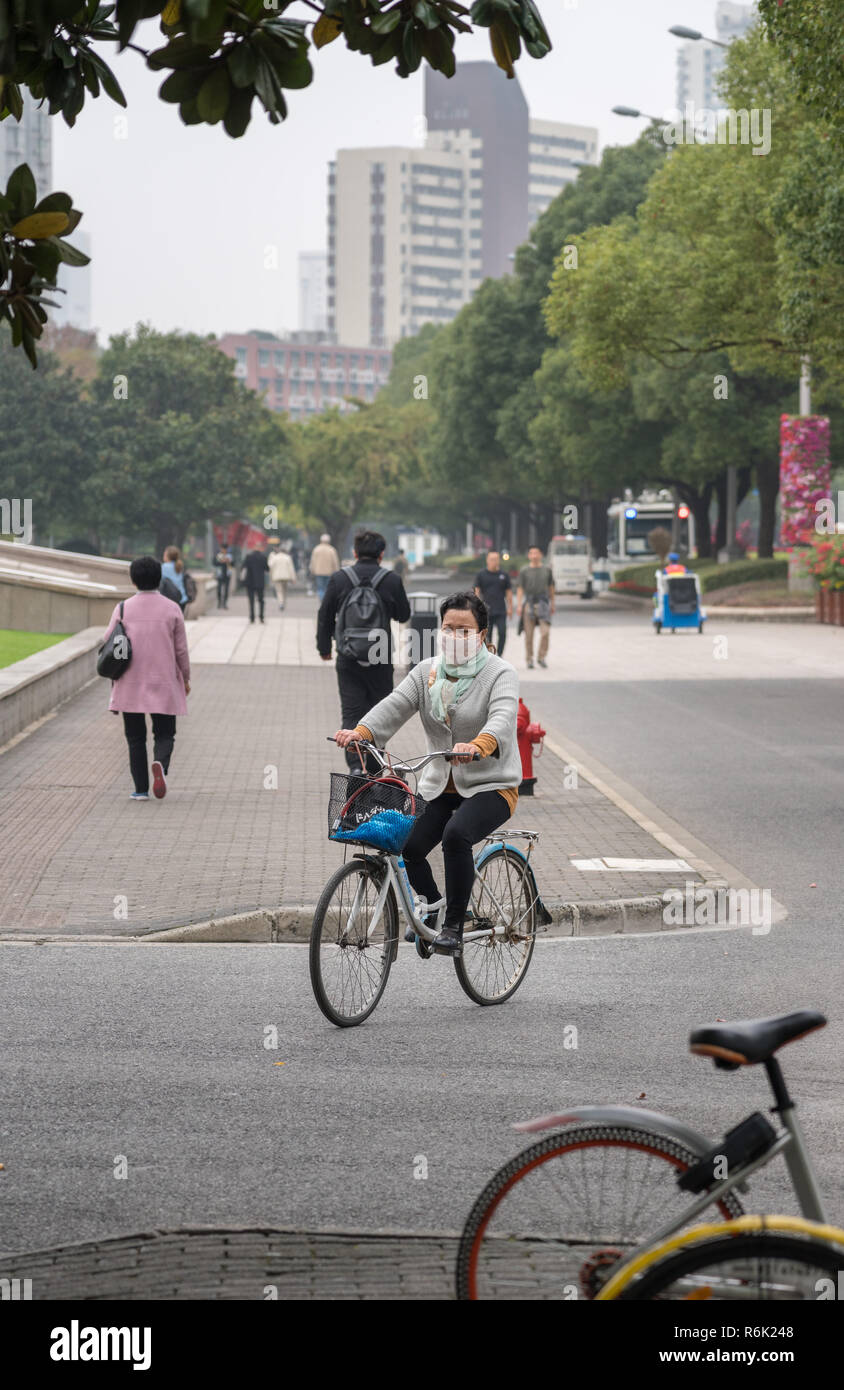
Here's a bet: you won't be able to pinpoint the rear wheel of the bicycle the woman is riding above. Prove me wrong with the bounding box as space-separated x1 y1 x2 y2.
455 845 537 1004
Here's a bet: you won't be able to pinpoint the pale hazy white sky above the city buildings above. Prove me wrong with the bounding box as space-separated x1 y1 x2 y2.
53 0 715 342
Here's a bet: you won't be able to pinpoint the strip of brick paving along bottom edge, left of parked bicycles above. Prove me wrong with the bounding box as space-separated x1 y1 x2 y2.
0 1229 457 1301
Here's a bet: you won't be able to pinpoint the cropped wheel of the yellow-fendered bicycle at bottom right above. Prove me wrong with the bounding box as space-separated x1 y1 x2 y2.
617 1232 844 1302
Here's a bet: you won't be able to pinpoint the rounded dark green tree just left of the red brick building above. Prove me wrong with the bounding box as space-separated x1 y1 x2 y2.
85 324 291 553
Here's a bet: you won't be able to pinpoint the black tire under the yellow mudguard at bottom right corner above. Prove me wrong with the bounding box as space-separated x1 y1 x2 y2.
616 1230 844 1302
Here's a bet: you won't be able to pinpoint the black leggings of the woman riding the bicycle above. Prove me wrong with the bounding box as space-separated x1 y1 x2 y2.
405 791 510 931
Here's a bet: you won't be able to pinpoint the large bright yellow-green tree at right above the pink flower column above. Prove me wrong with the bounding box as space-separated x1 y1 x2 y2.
546 24 844 386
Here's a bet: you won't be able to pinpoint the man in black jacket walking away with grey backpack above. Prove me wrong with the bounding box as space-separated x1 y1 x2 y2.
317 531 410 771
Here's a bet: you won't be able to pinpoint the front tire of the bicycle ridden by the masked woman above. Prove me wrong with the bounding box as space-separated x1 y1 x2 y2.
309 858 399 1029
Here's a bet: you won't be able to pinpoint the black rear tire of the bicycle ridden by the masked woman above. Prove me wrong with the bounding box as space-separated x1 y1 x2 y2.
455 845 537 1008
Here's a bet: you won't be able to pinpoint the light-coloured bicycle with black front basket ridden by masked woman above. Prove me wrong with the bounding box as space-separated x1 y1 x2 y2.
309 739 551 1027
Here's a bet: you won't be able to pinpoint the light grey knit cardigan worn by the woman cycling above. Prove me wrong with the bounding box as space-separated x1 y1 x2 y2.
360 653 521 801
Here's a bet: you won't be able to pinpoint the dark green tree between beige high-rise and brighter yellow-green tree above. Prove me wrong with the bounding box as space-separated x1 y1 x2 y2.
419 132 665 545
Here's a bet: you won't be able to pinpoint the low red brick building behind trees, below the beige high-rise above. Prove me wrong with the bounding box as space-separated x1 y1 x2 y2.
217 329 392 420
